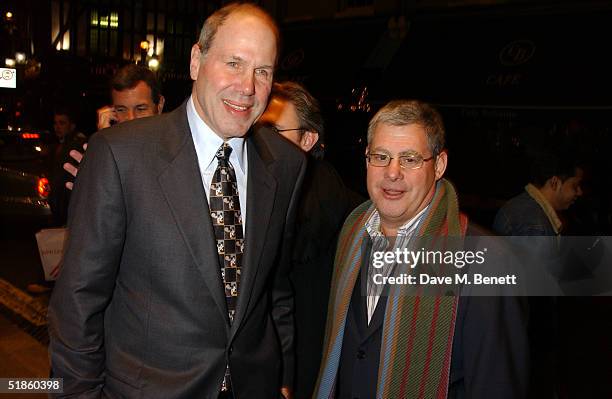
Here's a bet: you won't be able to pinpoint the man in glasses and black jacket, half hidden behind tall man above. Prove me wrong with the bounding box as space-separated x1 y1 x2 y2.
259 82 363 399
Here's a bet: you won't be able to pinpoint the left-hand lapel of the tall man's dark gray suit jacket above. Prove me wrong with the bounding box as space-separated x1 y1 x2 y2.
158 104 229 329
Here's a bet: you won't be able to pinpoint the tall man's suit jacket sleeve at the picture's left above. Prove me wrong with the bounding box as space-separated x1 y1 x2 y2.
48 134 127 398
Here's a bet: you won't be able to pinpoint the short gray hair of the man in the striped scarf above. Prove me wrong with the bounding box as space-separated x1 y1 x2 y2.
368 100 445 156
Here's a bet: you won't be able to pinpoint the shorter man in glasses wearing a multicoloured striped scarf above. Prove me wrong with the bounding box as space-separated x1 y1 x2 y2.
315 100 527 399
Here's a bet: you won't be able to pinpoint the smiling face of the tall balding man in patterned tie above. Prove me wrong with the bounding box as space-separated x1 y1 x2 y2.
190 11 277 139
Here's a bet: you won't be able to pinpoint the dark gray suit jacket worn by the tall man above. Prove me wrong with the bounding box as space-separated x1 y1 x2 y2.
49 105 305 398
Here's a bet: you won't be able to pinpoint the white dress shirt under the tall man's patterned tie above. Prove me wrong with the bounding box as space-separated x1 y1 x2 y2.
187 96 249 236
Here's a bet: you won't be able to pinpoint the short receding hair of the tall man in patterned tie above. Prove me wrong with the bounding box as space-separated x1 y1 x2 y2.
198 2 280 56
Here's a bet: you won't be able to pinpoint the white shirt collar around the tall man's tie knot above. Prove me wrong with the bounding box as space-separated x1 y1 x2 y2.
187 96 247 173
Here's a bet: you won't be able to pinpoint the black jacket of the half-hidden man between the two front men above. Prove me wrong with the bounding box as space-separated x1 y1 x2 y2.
290 157 364 399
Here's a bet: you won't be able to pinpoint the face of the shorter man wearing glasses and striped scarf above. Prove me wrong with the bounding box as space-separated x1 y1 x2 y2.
367 123 447 236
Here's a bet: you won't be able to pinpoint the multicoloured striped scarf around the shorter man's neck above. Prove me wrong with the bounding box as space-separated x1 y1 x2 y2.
315 179 467 399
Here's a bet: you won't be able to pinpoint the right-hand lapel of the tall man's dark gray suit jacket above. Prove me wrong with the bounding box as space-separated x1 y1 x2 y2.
231 137 277 336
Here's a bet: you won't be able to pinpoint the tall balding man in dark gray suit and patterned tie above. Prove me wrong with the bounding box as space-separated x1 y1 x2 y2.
49 4 305 398
